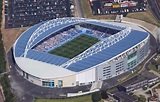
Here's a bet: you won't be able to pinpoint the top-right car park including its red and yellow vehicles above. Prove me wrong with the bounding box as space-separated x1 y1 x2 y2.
90 0 146 15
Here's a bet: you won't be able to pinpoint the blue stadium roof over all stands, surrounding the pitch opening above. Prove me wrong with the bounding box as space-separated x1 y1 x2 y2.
15 18 148 72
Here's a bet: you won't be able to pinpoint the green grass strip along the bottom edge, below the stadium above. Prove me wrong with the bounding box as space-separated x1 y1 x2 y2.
34 95 92 102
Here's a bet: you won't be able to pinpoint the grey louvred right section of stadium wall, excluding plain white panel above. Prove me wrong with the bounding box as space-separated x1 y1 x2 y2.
97 35 150 81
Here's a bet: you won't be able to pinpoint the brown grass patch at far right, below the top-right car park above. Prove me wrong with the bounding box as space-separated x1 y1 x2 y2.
127 7 160 27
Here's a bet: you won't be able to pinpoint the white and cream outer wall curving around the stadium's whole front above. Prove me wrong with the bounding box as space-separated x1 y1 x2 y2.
14 32 150 87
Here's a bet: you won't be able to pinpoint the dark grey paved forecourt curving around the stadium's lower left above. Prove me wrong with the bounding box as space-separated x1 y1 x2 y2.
8 51 91 102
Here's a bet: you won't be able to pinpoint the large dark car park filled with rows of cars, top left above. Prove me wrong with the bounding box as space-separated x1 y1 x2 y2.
4 0 72 28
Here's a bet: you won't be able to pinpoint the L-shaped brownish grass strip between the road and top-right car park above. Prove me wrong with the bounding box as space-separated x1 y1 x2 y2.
80 0 116 19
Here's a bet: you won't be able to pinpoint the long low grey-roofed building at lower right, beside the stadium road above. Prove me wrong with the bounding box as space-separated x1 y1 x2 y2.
118 72 159 93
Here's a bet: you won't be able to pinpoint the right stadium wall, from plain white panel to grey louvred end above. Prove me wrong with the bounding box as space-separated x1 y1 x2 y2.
76 34 150 85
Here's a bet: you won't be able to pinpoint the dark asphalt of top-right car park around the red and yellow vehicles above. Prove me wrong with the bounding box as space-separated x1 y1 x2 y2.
90 0 146 15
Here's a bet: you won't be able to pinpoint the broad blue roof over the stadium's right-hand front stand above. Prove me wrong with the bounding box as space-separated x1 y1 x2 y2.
68 30 148 72
